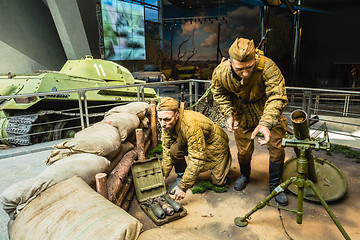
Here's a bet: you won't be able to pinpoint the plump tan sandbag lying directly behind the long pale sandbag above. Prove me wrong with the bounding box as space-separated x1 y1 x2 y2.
46 122 121 165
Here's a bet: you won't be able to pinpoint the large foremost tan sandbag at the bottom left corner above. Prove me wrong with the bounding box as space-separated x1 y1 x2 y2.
9 177 142 240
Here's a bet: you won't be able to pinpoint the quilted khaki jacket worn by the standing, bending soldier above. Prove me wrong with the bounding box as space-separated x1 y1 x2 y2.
211 54 288 129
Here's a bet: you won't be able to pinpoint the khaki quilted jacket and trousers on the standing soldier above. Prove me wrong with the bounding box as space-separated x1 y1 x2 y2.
211 52 287 169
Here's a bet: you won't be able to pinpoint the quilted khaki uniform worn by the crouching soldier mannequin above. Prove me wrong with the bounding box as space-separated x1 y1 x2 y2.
162 108 231 191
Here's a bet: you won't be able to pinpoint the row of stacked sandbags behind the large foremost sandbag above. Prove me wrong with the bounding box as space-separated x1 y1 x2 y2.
0 100 149 232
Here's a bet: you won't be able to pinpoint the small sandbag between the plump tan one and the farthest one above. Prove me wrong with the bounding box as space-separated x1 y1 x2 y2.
101 113 140 141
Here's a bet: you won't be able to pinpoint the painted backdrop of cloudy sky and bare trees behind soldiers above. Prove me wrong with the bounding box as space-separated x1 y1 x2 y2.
164 4 260 79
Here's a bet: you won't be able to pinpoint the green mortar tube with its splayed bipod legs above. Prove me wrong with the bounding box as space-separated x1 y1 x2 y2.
234 110 350 240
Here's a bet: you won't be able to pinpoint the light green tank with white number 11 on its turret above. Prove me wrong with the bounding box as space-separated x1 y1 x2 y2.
0 56 156 145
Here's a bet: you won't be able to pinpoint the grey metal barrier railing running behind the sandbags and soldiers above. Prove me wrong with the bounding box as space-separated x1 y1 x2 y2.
0 79 360 146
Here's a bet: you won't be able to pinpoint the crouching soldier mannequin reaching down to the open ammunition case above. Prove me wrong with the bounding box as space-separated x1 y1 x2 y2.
157 97 231 200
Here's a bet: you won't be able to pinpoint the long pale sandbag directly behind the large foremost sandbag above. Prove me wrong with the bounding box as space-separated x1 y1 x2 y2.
0 153 110 219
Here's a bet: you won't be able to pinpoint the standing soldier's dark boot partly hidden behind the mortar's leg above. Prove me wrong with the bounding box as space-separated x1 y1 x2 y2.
269 162 288 206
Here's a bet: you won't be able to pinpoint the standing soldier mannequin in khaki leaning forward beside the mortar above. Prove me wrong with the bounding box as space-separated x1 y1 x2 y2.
211 38 288 206
